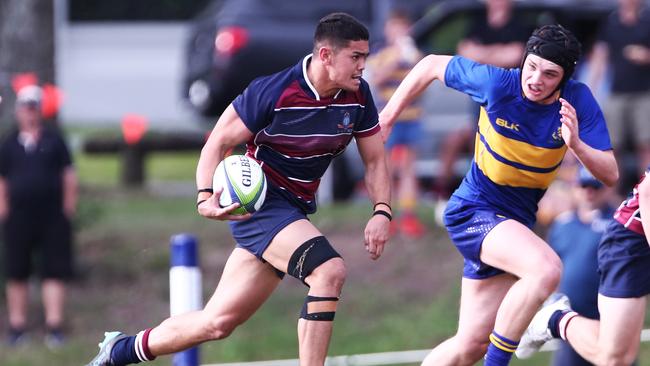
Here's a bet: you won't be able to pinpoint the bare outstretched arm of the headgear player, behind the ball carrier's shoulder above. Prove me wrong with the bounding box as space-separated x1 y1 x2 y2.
379 55 451 141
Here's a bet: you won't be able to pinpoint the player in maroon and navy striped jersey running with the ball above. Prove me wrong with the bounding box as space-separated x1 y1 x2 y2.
90 13 391 366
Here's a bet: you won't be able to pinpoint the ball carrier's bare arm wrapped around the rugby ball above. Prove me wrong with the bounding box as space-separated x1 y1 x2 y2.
196 104 253 220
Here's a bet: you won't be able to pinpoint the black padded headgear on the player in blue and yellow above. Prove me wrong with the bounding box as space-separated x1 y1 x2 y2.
521 24 582 88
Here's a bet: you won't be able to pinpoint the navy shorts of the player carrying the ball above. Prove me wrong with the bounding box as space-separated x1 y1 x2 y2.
230 185 307 262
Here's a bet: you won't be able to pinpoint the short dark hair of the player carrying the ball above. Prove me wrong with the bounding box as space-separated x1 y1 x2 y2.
314 13 370 51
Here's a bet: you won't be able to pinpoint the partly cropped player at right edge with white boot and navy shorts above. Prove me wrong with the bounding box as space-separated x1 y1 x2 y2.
517 166 650 365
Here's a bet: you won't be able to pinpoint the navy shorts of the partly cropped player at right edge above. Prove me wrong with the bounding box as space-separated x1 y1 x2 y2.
598 221 650 298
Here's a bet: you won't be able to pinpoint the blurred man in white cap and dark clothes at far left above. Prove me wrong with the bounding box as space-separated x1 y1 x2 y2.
0 86 77 347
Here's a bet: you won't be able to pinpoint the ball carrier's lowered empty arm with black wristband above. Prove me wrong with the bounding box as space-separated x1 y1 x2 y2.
357 134 392 259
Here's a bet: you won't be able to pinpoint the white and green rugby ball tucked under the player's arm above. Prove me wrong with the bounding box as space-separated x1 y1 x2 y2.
212 155 266 215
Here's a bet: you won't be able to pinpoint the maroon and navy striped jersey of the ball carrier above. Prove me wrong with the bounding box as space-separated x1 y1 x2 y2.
233 55 380 213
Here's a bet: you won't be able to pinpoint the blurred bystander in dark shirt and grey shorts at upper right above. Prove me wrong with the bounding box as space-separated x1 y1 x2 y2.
588 0 650 194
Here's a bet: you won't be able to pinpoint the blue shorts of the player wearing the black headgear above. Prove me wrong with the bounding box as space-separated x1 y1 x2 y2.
444 196 508 280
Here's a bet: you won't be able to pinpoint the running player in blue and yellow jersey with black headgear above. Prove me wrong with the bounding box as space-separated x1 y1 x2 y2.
379 25 618 366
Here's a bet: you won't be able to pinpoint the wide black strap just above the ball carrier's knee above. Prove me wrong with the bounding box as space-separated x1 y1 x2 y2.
287 236 341 286
